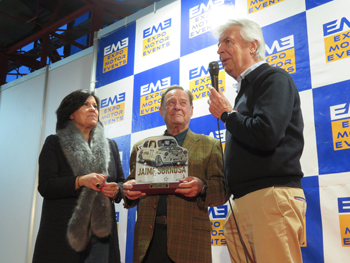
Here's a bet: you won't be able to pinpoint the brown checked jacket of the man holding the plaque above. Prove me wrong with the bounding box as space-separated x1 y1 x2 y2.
125 130 227 263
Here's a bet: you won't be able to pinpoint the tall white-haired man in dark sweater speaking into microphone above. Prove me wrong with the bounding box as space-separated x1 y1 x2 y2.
208 19 306 263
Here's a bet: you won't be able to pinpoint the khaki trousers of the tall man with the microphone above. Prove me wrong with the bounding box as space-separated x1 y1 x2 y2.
224 187 306 263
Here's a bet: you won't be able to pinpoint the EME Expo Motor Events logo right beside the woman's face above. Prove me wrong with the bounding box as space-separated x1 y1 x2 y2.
100 92 125 126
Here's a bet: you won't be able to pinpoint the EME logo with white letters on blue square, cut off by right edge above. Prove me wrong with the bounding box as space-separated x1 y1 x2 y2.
330 103 350 151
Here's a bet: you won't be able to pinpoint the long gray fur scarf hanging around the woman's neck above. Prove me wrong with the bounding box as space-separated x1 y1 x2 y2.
57 122 112 252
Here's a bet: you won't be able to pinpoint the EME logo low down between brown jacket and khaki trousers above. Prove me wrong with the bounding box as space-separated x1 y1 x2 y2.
208 205 227 246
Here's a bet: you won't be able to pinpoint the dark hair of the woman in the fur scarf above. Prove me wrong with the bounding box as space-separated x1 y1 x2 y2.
56 89 100 131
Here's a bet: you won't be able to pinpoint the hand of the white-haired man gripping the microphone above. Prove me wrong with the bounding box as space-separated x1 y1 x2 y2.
208 86 233 119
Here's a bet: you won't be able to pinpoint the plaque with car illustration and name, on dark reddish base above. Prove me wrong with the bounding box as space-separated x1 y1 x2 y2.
133 136 188 194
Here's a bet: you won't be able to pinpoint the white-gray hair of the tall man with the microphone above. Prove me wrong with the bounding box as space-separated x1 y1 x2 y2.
213 18 265 60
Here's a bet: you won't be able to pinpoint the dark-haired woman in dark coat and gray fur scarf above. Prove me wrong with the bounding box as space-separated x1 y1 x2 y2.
33 90 124 263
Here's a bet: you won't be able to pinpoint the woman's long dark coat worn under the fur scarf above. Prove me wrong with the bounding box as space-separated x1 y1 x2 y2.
33 135 124 263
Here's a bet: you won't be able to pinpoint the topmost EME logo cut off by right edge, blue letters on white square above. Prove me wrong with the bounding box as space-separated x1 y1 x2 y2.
323 17 350 63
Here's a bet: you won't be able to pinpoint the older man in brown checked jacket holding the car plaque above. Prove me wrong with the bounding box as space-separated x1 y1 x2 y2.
124 86 227 263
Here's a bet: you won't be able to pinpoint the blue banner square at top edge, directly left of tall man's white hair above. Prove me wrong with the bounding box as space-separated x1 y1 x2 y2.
181 0 235 56
